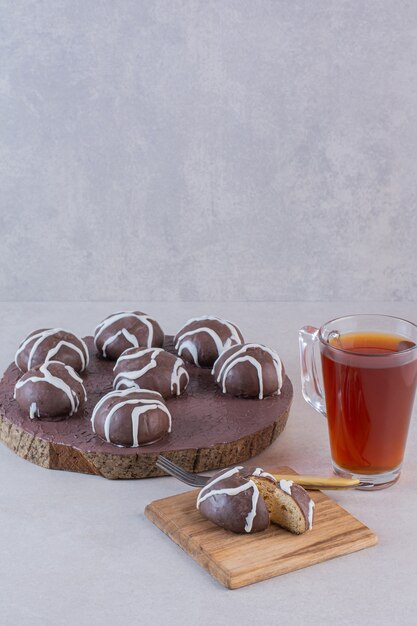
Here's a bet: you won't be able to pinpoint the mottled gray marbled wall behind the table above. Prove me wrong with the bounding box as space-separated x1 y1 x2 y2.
0 0 417 301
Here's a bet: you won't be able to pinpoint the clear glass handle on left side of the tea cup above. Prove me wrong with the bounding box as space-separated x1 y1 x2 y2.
299 326 327 417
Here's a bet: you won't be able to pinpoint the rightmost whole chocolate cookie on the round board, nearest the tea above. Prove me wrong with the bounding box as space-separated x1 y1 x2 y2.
212 343 285 400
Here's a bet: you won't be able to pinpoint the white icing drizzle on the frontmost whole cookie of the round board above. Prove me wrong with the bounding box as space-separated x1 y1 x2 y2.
91 389 172 448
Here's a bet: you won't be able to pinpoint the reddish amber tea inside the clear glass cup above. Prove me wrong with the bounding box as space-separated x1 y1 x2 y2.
321 332 417 474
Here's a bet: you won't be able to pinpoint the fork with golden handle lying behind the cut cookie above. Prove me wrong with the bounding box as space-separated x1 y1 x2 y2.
156 455 373 489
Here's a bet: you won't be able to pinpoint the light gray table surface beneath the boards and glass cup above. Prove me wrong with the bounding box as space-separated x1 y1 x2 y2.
0 302 417 626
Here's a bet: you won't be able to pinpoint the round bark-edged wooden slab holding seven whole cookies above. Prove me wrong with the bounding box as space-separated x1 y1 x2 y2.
0 337 293 479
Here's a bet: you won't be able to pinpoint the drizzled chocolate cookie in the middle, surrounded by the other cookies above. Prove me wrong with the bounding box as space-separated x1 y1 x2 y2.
113 348 189 398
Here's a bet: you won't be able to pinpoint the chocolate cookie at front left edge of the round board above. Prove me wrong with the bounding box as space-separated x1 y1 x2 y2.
14 361 87 419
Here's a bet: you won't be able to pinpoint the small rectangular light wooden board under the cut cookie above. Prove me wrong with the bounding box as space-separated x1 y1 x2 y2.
145 467 378 589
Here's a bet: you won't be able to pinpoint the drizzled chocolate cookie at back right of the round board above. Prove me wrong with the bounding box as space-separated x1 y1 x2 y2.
174 315 243 367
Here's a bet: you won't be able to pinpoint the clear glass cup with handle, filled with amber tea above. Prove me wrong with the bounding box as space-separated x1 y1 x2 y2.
299 315 417 489
